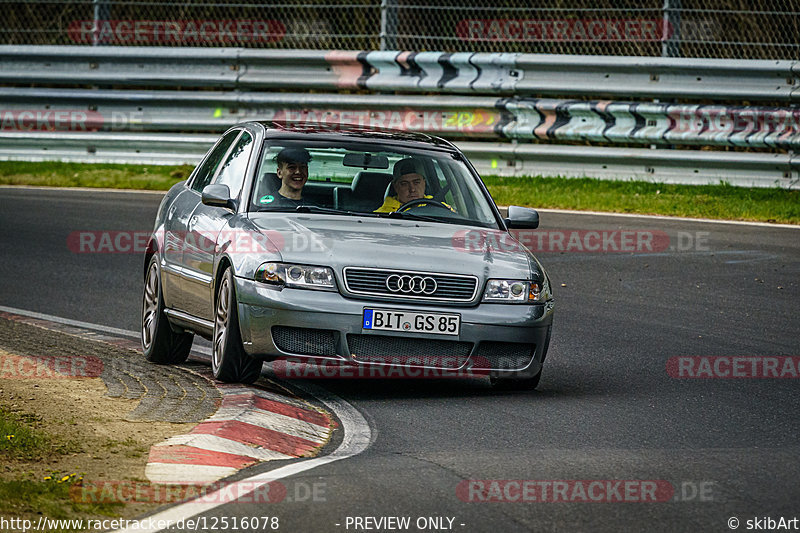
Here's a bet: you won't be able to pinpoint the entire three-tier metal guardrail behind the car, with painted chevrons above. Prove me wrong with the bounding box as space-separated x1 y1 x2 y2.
0 46 800 187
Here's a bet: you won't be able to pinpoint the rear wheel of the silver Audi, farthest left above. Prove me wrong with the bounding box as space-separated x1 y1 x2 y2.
141 255 194 365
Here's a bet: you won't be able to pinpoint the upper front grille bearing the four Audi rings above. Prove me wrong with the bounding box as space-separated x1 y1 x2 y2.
344 267 478 302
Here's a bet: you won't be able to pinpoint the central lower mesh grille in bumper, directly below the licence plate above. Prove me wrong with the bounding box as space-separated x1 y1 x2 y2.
347 333 472 369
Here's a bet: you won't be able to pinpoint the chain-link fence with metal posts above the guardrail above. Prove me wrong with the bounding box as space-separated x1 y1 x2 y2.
0 0 800 59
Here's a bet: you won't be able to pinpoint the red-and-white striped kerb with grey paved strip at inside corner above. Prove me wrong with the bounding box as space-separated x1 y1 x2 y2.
0 308 346 490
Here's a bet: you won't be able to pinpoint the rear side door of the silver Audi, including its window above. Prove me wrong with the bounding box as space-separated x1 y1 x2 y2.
161 131 239 309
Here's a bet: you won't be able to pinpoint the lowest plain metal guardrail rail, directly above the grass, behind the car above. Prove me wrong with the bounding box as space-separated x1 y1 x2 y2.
0 131 800 188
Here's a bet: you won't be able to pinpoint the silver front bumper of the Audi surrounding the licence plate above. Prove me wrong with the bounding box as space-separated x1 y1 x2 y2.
235 277 553 377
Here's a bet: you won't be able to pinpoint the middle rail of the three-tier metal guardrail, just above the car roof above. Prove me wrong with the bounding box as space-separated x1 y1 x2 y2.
0 87 800 150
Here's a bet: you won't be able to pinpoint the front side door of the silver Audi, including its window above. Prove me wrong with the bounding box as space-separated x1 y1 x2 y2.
183 131 254 320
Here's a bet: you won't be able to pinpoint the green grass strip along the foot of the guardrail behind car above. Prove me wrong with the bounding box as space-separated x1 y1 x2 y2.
0 161 800 224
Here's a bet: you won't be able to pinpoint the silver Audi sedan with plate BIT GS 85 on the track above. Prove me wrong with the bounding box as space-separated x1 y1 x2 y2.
141 122 553 388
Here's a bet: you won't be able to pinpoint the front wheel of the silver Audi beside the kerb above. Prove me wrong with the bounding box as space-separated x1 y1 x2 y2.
211 267 263 384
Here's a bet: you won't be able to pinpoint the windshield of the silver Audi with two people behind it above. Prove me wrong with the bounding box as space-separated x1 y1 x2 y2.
249 140 497 228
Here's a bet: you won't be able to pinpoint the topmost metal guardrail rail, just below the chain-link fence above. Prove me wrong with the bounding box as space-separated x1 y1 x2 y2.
0 45 800 102
